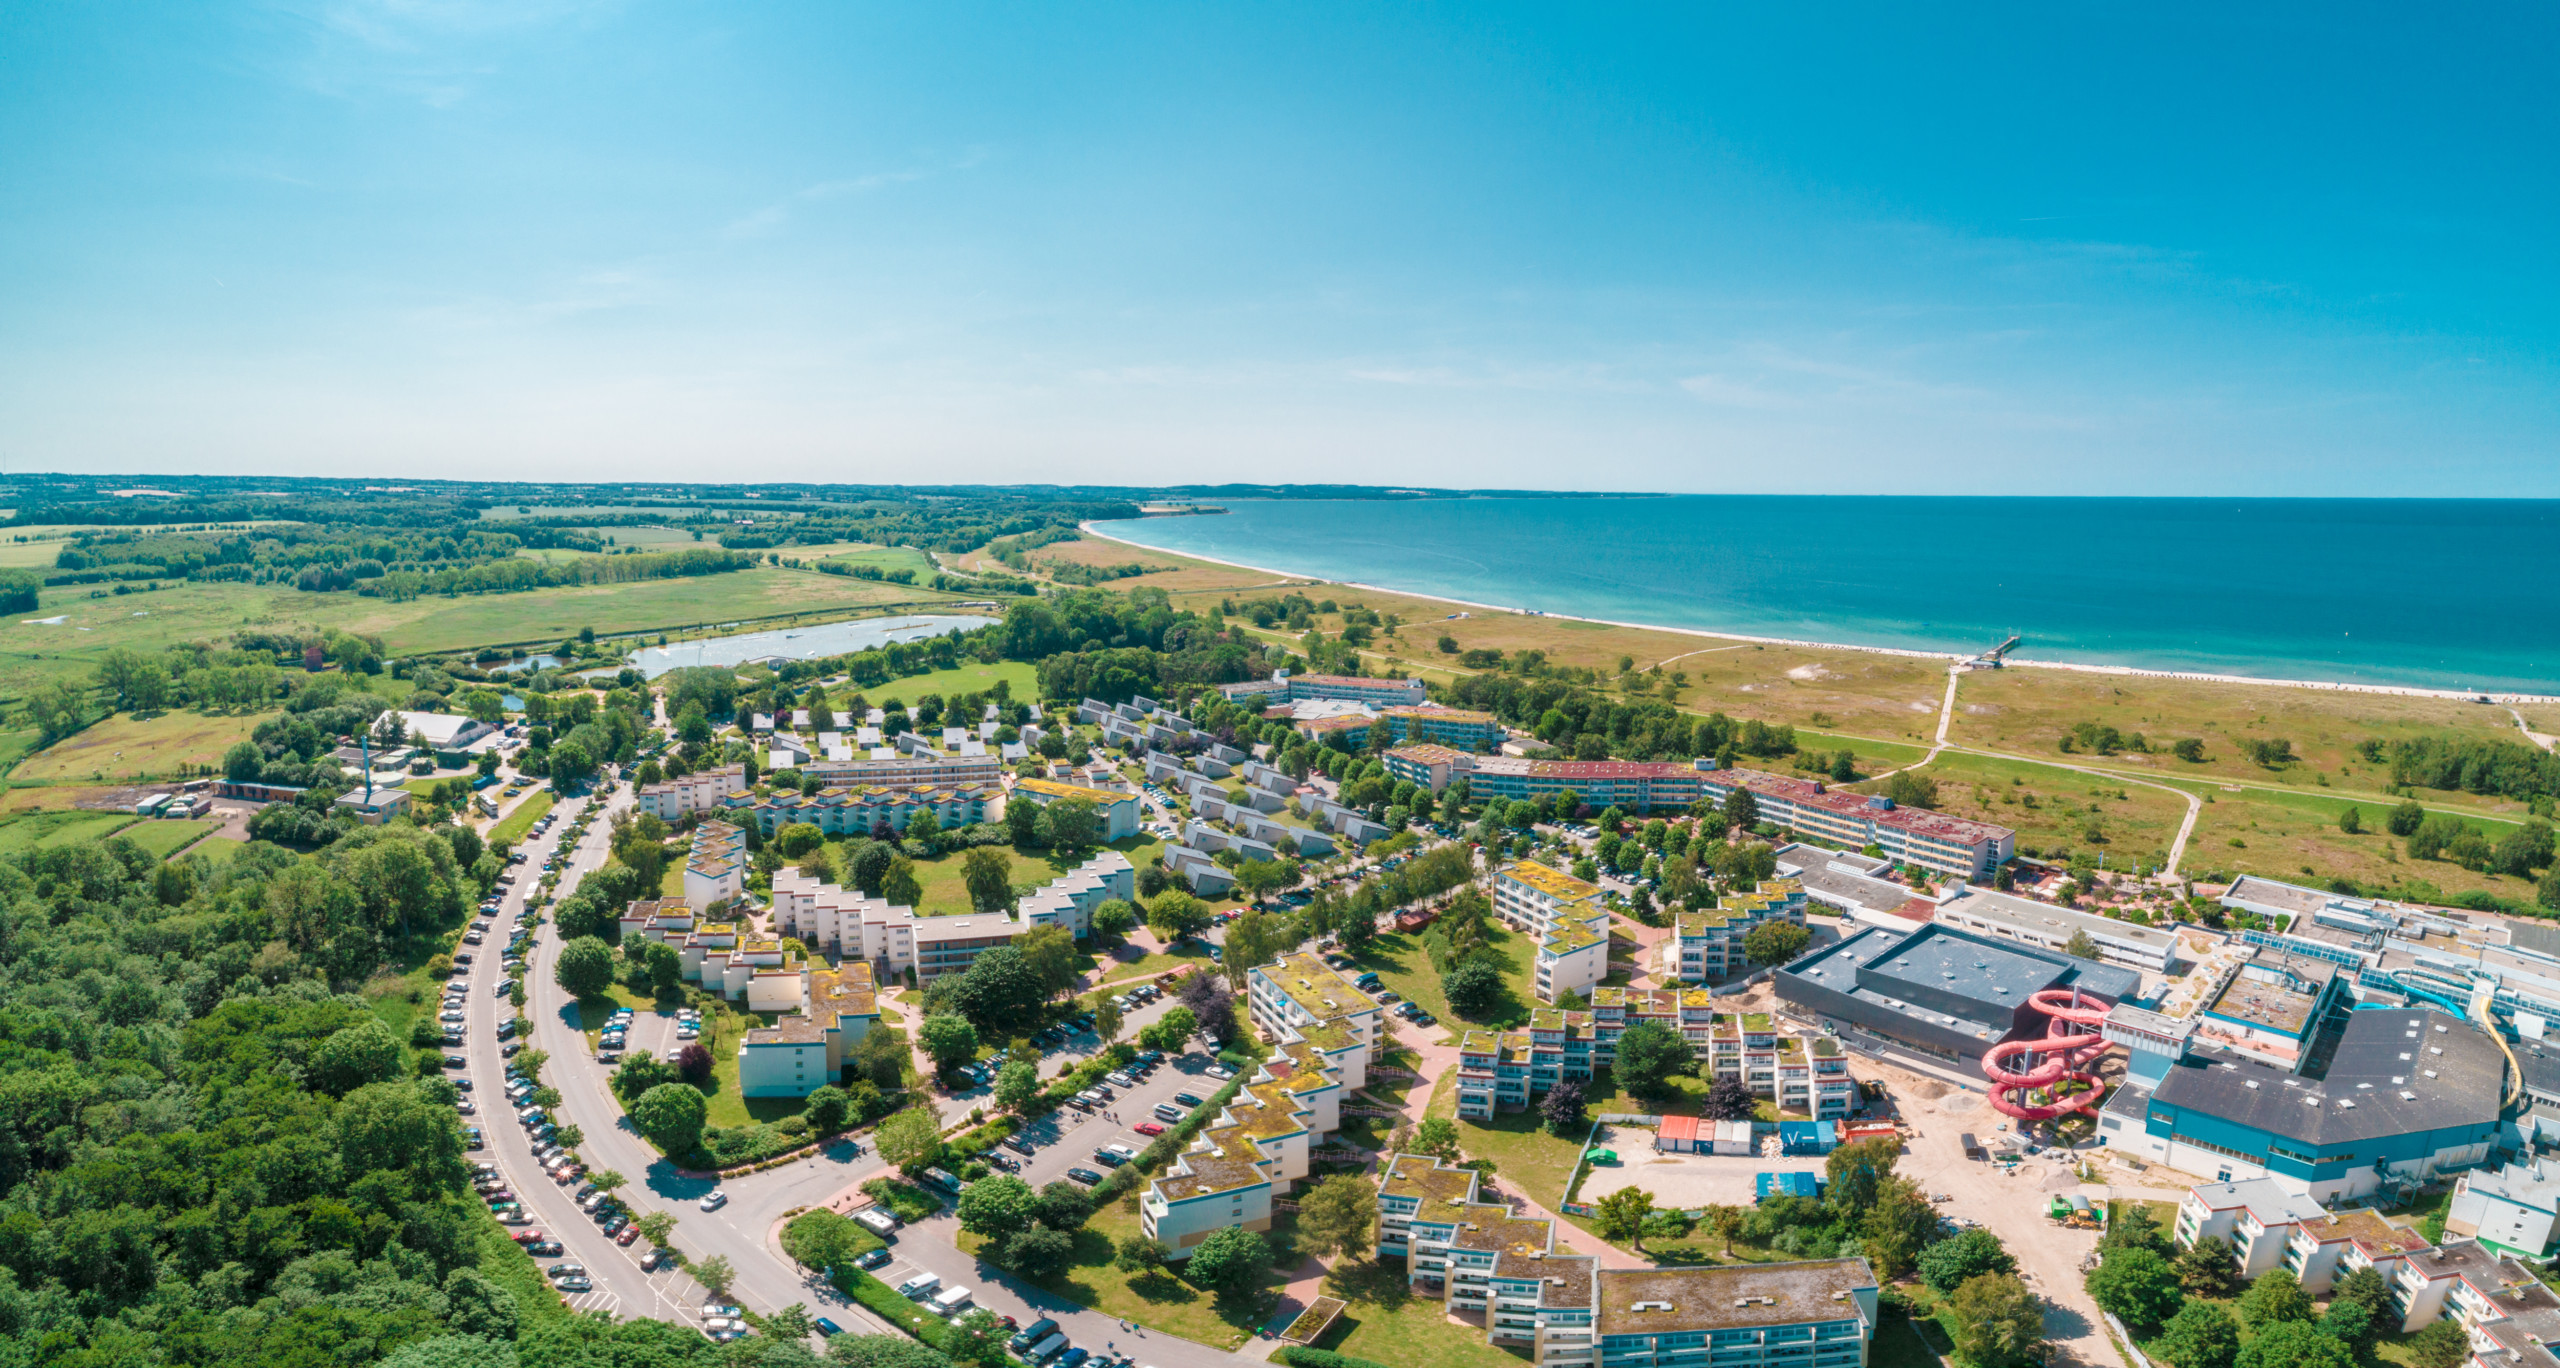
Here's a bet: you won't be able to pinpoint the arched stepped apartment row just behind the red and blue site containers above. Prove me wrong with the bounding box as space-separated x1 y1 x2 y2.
1457 989 1859 1122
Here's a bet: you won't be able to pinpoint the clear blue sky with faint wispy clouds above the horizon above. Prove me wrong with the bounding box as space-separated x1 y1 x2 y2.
0 0 2560 497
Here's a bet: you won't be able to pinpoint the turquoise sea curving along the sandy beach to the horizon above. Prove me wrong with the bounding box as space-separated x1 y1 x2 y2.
1098 494 2560 694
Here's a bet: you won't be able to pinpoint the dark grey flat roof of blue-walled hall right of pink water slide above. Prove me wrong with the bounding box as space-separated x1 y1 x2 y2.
2153 1007 2506 1145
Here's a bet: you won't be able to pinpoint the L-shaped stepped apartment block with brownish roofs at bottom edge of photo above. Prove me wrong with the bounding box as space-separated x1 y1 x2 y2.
1377 1155 1879 1368
